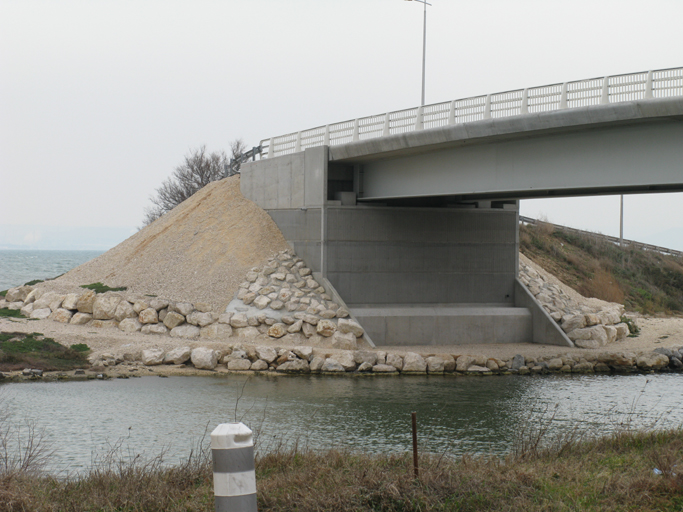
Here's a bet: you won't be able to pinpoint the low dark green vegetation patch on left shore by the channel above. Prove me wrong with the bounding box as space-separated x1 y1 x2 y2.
0 332 89 372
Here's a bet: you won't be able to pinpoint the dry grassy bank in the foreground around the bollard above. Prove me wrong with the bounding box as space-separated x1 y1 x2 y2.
0 430 683 511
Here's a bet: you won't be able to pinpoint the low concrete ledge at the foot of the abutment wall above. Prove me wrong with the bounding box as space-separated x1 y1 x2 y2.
350 304 533 346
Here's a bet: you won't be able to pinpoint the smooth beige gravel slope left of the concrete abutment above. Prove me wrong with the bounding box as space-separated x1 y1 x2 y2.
42 176 289 311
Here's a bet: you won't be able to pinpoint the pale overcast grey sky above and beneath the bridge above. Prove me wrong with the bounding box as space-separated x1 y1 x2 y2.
0 0 683 250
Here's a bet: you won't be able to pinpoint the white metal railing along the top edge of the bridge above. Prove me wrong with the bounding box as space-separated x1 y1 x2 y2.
261 68 683 158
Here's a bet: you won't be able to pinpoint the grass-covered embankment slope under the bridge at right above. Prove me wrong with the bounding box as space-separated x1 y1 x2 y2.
519 223 683 316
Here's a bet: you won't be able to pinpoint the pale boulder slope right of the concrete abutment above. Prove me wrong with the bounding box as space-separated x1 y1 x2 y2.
519 262 629 348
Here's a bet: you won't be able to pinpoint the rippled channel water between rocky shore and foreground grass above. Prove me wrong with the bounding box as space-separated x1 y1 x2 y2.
0 374 683 472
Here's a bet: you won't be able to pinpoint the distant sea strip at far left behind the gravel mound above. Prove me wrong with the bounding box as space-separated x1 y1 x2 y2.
0 250 104 290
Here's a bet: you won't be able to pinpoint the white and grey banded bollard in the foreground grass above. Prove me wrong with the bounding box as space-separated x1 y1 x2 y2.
211 423 258 512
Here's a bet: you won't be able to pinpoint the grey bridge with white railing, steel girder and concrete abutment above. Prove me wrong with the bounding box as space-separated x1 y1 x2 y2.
241 68 683 346
